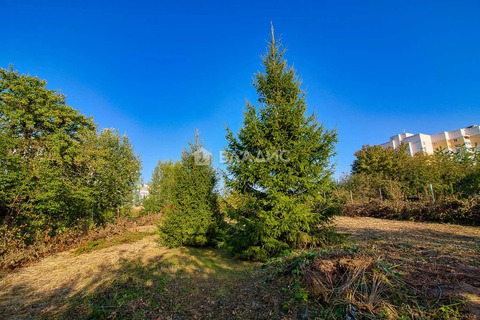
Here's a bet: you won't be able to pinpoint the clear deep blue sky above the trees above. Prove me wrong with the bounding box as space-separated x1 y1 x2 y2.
0 0 480 181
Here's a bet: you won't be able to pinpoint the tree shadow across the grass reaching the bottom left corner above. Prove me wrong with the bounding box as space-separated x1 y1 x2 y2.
0 248 283 319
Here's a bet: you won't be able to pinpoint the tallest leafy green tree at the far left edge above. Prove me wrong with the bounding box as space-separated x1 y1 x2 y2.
0 67 95 234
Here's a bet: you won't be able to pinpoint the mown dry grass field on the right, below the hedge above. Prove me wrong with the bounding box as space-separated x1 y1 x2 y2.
336 217 480 319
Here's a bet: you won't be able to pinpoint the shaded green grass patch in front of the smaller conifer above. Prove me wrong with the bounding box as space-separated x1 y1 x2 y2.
61 248 282 319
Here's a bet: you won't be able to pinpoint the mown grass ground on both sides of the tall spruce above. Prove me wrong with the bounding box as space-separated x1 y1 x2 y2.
0 217 480 319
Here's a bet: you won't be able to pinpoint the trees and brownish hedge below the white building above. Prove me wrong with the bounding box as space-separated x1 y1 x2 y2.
331 145 480 225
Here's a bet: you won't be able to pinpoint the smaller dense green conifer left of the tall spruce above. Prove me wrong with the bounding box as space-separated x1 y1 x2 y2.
159 135 222 247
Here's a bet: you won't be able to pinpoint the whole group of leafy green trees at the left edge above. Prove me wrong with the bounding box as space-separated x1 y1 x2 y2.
0 66 141 242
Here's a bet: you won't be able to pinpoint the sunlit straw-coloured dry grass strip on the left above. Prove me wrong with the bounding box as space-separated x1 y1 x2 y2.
0 236 165 319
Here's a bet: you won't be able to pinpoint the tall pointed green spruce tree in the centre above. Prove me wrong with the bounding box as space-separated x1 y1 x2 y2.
226 26 337 260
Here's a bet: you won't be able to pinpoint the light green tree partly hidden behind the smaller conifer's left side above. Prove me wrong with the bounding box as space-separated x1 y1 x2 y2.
143 160 181 212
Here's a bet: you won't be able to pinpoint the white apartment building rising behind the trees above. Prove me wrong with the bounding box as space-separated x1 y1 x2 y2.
380 125 480 155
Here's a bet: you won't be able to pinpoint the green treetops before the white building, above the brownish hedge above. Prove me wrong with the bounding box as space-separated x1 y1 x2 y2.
343 145 480 200
